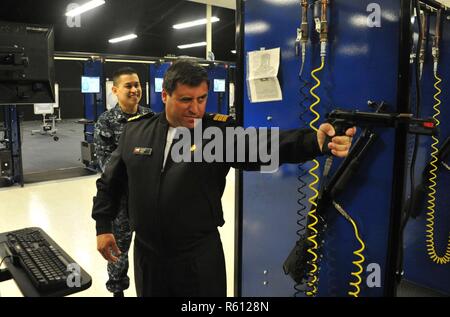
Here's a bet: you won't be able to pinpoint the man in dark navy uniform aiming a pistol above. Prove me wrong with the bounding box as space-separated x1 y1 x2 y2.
92 60 355 296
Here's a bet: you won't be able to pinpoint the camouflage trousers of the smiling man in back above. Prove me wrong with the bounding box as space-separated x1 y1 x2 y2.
106 199 132 293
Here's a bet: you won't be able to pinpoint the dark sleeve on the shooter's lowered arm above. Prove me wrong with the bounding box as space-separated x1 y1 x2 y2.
92 126 128 235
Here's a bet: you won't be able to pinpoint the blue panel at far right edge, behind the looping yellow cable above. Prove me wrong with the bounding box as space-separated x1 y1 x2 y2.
404 15 450 294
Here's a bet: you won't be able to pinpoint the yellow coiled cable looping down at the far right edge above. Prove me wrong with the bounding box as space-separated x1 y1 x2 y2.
426 73 450 264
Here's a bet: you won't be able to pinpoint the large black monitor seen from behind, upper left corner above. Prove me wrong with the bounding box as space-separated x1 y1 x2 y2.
0 21 55 105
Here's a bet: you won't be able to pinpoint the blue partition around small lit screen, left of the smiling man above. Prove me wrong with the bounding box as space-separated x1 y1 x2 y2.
80 61 106 142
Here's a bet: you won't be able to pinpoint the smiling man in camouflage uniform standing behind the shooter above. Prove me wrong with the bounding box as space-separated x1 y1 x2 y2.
94 67 150 297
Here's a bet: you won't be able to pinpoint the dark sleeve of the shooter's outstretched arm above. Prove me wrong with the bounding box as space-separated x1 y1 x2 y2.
219 117 322 171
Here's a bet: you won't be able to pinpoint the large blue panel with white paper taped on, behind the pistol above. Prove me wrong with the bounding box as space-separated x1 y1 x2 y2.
241 0 400 296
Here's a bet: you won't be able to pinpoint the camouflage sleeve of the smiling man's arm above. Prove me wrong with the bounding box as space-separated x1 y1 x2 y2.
94 116 117 172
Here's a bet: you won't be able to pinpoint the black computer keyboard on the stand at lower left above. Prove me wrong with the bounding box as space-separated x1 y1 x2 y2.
7 228 73 292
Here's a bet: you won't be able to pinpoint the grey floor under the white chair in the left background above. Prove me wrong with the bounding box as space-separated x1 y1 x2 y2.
21 119 84 175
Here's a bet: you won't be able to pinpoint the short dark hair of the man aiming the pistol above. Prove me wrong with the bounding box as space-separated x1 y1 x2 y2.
163 59 209 95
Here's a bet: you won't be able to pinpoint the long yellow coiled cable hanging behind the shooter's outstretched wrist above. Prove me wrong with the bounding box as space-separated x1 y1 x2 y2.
306 58 325 296
